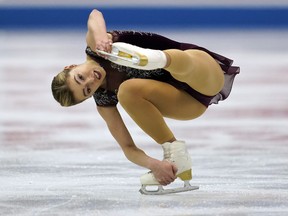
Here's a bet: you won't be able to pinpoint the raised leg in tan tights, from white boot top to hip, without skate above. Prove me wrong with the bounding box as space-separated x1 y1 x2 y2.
164 49 224 96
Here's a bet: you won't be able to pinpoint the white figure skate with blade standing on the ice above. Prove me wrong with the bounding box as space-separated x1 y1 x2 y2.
140 141 199 195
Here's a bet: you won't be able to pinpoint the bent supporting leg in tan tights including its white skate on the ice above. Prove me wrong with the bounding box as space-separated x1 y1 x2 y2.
118 79 202 194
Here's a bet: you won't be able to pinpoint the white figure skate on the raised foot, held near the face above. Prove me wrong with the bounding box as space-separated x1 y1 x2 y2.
96 42 167 70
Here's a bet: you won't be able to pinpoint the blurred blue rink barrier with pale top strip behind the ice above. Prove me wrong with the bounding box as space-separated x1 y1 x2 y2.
0 0 288 29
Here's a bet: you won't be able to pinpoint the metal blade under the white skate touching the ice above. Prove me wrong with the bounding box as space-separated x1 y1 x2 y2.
139 182 199 195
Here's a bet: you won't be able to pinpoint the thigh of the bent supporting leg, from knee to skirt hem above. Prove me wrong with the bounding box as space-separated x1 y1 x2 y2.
121 79 207 120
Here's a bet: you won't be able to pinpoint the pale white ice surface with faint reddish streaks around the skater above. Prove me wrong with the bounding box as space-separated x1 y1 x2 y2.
0 31 288 216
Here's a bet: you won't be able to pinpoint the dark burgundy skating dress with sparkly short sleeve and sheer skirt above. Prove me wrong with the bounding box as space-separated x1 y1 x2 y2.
86 31 240 107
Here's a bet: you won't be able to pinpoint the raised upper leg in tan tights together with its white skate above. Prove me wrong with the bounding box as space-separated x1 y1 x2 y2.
109 42 224 96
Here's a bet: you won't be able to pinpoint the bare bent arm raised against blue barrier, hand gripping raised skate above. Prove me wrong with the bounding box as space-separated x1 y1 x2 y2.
86 9 112 52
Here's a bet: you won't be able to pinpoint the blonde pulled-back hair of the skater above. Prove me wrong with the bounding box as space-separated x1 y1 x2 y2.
51 69 82 107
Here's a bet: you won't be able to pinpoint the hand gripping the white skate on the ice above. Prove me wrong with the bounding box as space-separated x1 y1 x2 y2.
152 160 177 185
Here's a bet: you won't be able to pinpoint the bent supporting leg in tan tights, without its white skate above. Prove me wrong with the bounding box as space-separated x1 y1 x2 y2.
118 79 206 144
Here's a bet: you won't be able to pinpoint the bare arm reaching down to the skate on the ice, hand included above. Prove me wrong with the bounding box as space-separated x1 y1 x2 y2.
97 106 177 185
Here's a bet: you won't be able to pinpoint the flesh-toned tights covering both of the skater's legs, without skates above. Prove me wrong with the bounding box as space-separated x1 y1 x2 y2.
118 49 224 144
